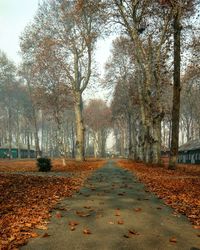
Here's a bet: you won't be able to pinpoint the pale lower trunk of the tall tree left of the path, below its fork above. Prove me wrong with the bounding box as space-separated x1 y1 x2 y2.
74 91 84 161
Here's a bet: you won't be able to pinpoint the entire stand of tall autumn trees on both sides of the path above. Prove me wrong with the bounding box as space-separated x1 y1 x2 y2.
2 0 199 168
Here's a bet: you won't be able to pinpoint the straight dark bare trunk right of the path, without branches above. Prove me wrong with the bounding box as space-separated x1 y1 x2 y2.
169 10 181 169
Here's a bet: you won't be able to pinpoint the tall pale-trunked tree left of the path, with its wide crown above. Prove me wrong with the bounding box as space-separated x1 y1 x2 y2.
21 0 104 160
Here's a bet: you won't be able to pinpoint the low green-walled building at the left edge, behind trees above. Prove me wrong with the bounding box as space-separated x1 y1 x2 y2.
0 144 36 159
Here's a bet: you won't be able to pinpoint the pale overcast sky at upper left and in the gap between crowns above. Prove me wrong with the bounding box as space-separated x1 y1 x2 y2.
0 0 111 72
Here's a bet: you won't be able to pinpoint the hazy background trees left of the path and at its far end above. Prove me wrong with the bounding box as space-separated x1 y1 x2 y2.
0 49 111 159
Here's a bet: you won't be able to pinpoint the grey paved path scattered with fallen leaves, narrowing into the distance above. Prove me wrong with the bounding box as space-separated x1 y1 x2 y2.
21 161 200 250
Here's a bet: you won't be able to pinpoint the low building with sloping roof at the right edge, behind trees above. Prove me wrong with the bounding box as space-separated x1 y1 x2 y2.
178 139 200 164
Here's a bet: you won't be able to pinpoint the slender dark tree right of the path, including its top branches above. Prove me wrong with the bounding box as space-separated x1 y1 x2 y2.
161 0 197 169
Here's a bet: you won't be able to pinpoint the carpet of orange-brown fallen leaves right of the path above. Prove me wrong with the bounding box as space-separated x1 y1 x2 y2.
118 160 200 226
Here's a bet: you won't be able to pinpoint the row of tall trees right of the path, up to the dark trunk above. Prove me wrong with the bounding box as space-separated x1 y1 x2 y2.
106 0 199 168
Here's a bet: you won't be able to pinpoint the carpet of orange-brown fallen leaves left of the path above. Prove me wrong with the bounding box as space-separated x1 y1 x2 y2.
0 159 104 250
